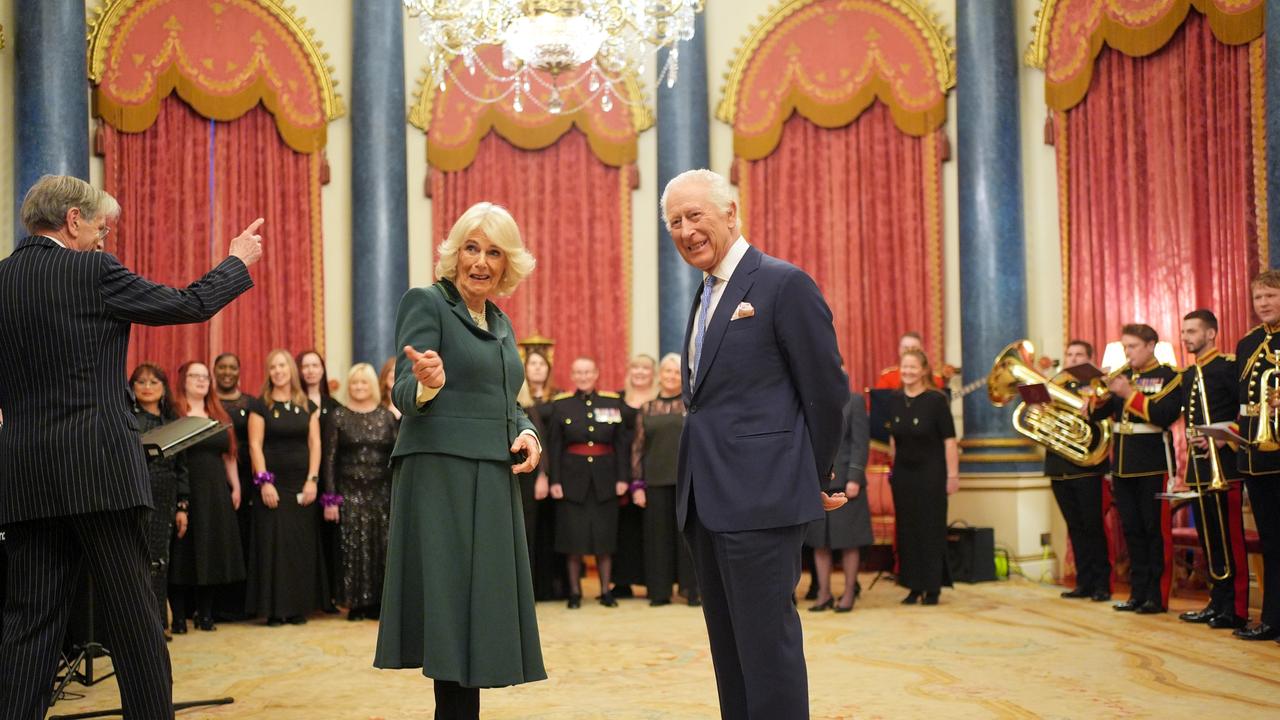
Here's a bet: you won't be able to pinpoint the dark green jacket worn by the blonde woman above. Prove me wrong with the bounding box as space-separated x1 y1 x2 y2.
392 279 536 462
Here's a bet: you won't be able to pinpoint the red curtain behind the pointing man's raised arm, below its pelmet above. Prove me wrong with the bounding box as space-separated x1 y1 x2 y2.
101 96 323 392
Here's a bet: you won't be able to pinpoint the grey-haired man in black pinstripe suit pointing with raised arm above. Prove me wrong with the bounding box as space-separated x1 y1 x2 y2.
0 176 262 720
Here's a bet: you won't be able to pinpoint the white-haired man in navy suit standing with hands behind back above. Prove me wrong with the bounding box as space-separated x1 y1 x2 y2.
662 170 849 720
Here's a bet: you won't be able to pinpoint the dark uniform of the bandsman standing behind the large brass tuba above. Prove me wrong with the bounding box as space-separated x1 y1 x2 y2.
1044 372 1111 600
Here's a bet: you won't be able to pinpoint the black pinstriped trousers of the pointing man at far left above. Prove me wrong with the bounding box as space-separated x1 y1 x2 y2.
0 507 173 720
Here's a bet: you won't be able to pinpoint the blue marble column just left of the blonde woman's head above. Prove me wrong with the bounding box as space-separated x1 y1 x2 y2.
351 0 408 368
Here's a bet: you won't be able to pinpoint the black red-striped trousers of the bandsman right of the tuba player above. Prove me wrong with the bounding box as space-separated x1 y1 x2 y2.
1111 475 1167 605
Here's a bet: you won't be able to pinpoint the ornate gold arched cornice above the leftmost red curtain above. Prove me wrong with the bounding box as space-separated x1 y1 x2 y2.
86 0 347 120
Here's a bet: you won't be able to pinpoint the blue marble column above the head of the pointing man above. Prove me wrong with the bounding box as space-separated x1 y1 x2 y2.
9 0 88 237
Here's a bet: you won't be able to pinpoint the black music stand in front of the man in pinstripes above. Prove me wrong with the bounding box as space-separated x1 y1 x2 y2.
49 418 236 720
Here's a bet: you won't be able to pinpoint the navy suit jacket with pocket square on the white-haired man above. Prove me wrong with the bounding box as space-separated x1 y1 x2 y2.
676 247 849 532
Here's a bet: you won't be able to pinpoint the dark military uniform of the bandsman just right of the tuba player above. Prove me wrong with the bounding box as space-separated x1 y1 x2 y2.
1093 360 1183 611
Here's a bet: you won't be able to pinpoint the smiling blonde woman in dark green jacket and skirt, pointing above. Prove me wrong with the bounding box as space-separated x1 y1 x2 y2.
374 202 547 719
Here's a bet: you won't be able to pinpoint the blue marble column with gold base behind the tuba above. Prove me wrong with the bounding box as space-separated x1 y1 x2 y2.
956 0 1034 473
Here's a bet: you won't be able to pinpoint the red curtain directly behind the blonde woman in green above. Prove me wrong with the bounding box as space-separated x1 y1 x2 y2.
431 128 634 389
